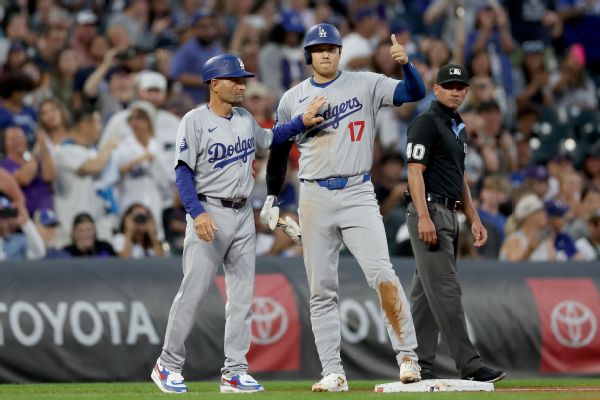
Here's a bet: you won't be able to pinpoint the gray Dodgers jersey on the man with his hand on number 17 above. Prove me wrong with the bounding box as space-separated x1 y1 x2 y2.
175 105 273 199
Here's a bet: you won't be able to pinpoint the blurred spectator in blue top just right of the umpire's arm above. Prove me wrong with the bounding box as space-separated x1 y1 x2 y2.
476 175 510 258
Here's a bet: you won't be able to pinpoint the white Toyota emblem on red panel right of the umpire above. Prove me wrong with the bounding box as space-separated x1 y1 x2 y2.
550 300 597 349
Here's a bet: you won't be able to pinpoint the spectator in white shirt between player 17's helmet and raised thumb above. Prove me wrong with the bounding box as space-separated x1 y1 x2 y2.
340 7 379 70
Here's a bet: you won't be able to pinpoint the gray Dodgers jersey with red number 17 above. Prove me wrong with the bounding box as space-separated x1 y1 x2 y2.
276 71 400 180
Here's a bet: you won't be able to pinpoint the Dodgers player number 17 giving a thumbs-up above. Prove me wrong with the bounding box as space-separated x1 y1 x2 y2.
261 24 425 392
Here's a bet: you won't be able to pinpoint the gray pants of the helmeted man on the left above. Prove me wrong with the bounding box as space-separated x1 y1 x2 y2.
160 202 256 376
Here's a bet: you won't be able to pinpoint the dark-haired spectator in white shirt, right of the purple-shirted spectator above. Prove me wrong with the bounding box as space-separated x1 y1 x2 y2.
54 109 118 245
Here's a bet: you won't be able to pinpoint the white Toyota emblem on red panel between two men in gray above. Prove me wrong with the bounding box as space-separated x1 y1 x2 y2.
252 297 288 345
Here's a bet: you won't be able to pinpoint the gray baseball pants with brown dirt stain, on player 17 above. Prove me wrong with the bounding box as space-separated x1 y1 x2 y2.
299 176 417 376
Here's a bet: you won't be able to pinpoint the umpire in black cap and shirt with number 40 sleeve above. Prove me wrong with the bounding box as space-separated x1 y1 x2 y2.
406 64 505 382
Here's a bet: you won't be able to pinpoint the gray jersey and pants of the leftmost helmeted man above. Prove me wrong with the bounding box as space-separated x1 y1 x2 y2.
160 105 273 375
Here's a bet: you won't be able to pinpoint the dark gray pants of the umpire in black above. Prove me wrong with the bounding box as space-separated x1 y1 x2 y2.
406 203 483 376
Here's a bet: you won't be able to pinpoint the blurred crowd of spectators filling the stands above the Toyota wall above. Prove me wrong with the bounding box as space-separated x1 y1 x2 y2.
0 0 600 261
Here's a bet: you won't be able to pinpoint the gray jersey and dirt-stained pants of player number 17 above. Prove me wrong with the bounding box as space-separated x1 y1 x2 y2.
277 71 417 376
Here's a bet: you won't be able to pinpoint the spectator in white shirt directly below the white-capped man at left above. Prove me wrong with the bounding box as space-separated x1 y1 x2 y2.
109 100 174 240
